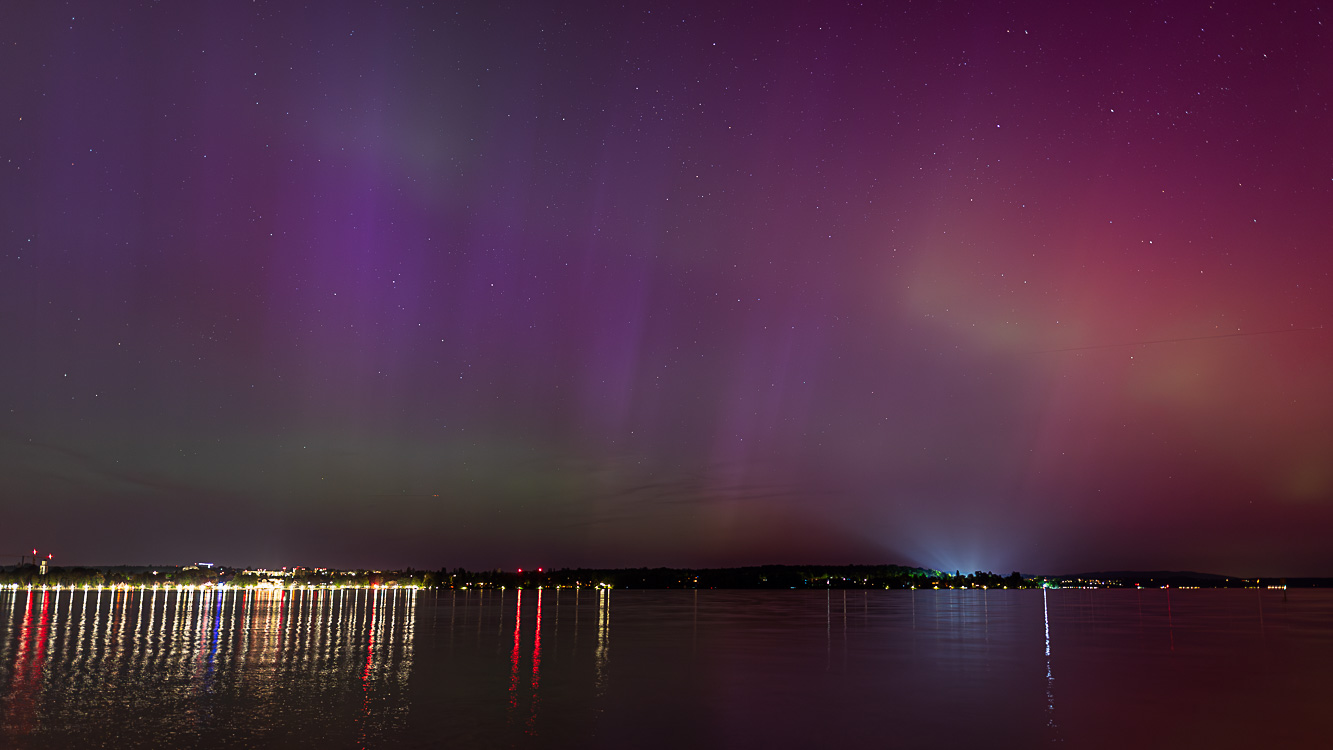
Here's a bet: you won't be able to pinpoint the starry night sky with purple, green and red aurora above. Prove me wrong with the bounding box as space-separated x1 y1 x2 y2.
0 1 1333 575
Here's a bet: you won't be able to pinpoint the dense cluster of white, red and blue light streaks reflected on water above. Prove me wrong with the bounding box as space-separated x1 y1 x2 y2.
0 589 416 747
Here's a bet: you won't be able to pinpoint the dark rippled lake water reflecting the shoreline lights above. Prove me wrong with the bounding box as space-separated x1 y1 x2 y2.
0 589 1333 749
